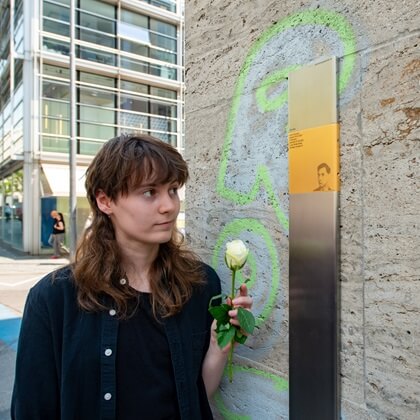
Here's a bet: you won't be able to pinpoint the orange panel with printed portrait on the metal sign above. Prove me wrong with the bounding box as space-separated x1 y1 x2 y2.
289 124 340 194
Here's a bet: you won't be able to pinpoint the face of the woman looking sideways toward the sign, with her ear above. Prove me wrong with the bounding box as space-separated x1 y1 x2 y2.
96 182 180 246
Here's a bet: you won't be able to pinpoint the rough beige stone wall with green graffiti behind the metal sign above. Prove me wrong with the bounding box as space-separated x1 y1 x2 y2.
185 0 420 420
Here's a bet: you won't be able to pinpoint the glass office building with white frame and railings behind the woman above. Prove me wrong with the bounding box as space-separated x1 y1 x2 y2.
0 0 183 254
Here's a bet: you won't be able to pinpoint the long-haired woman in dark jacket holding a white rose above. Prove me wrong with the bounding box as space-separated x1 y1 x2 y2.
12 135 252 420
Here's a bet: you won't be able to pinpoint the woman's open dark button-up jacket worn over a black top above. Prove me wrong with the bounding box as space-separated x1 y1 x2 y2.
11 265 220 420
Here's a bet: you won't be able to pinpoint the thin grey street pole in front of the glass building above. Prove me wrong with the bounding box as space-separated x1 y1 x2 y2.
69 0 77 257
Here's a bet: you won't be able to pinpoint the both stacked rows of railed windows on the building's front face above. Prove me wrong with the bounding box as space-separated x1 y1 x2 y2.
41 0 181 155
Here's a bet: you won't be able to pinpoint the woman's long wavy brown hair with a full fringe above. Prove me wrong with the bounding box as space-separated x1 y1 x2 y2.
72 134 202 318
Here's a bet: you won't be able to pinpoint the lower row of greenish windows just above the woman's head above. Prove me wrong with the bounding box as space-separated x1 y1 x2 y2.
40 64 178 155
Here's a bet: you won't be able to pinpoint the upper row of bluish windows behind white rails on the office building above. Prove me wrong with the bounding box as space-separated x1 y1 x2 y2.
42 0 179 80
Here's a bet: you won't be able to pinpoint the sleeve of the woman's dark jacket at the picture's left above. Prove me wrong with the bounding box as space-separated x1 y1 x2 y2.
11 289 60 420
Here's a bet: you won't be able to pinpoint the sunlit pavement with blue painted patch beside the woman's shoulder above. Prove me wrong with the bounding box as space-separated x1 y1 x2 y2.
0 243 68 420
